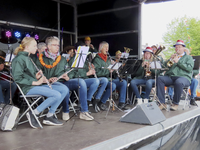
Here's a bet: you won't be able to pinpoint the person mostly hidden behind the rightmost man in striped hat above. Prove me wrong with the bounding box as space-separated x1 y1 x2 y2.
168 48 199 106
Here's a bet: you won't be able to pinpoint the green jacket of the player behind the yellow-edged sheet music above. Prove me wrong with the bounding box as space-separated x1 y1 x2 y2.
68 56 89 79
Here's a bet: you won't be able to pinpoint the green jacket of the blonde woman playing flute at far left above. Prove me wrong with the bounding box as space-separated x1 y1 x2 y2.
12 52 37 94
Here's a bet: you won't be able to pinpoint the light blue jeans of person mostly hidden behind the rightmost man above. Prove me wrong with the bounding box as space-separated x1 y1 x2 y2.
168 78 198 99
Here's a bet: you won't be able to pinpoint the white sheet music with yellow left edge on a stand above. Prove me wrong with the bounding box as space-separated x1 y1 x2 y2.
72 46 89 68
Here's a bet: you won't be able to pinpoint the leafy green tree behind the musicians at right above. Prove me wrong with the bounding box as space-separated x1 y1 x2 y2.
163 17 200 58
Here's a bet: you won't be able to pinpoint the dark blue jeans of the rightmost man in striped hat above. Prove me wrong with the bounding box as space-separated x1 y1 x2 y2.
157 76 190 105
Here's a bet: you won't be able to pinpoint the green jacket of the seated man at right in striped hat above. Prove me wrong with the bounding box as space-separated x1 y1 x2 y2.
164 54 194 82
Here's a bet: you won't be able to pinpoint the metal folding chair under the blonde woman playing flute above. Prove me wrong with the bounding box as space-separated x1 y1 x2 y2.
16 83 45 128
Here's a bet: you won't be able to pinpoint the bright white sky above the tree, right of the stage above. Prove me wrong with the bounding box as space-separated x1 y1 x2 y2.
142 0 200 46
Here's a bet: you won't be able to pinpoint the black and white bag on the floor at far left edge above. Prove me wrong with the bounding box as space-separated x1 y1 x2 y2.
0 104 19 131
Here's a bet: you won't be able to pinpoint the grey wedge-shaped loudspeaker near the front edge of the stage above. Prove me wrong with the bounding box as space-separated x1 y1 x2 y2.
120 102 166 125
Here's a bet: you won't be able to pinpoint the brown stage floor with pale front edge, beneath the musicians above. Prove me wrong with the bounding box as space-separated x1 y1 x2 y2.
0 102 200 150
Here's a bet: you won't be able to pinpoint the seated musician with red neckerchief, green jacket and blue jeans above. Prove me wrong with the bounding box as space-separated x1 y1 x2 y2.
93 41 127 110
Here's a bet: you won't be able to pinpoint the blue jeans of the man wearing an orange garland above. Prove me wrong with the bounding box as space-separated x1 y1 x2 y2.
62 78 88 113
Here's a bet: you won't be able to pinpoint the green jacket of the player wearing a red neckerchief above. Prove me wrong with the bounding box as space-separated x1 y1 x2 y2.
92 54 111 78
